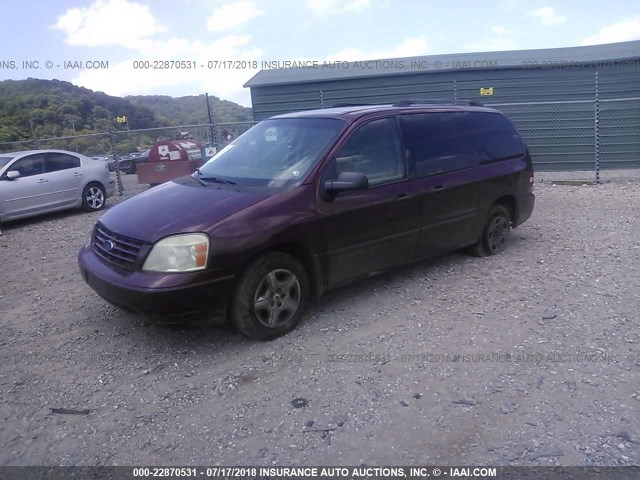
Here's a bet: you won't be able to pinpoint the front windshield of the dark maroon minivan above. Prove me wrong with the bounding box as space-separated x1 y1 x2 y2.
198 118 346 191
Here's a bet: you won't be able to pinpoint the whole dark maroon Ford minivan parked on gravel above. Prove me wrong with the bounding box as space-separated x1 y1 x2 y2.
79 101 534 339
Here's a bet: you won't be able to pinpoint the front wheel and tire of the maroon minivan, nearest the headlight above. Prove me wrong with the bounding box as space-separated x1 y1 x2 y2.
230 252 309 340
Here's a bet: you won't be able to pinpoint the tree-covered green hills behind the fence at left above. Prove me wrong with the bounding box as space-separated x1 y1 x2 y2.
0 78 252 155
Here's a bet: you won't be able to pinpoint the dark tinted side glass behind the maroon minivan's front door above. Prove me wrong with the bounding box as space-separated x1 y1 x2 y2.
402 112 525 177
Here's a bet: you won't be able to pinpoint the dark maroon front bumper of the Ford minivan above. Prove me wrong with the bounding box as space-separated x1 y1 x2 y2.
78 245 235 324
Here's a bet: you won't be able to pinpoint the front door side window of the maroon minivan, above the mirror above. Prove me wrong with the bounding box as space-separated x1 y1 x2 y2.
335 118 406 186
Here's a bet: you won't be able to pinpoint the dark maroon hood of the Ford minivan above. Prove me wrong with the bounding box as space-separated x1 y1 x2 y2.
100 180 268 243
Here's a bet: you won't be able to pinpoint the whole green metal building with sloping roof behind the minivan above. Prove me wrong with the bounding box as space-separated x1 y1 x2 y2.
245 41 640 171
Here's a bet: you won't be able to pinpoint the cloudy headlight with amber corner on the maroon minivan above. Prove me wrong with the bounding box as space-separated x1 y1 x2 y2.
142 233 209 272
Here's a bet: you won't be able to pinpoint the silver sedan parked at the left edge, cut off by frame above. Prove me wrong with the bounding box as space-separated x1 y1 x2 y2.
0 150 115 222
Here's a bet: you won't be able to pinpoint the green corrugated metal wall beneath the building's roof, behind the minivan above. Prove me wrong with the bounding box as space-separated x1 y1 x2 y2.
251 61 640 170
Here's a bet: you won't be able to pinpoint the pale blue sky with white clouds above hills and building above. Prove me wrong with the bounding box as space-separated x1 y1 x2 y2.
0 0 640 106
